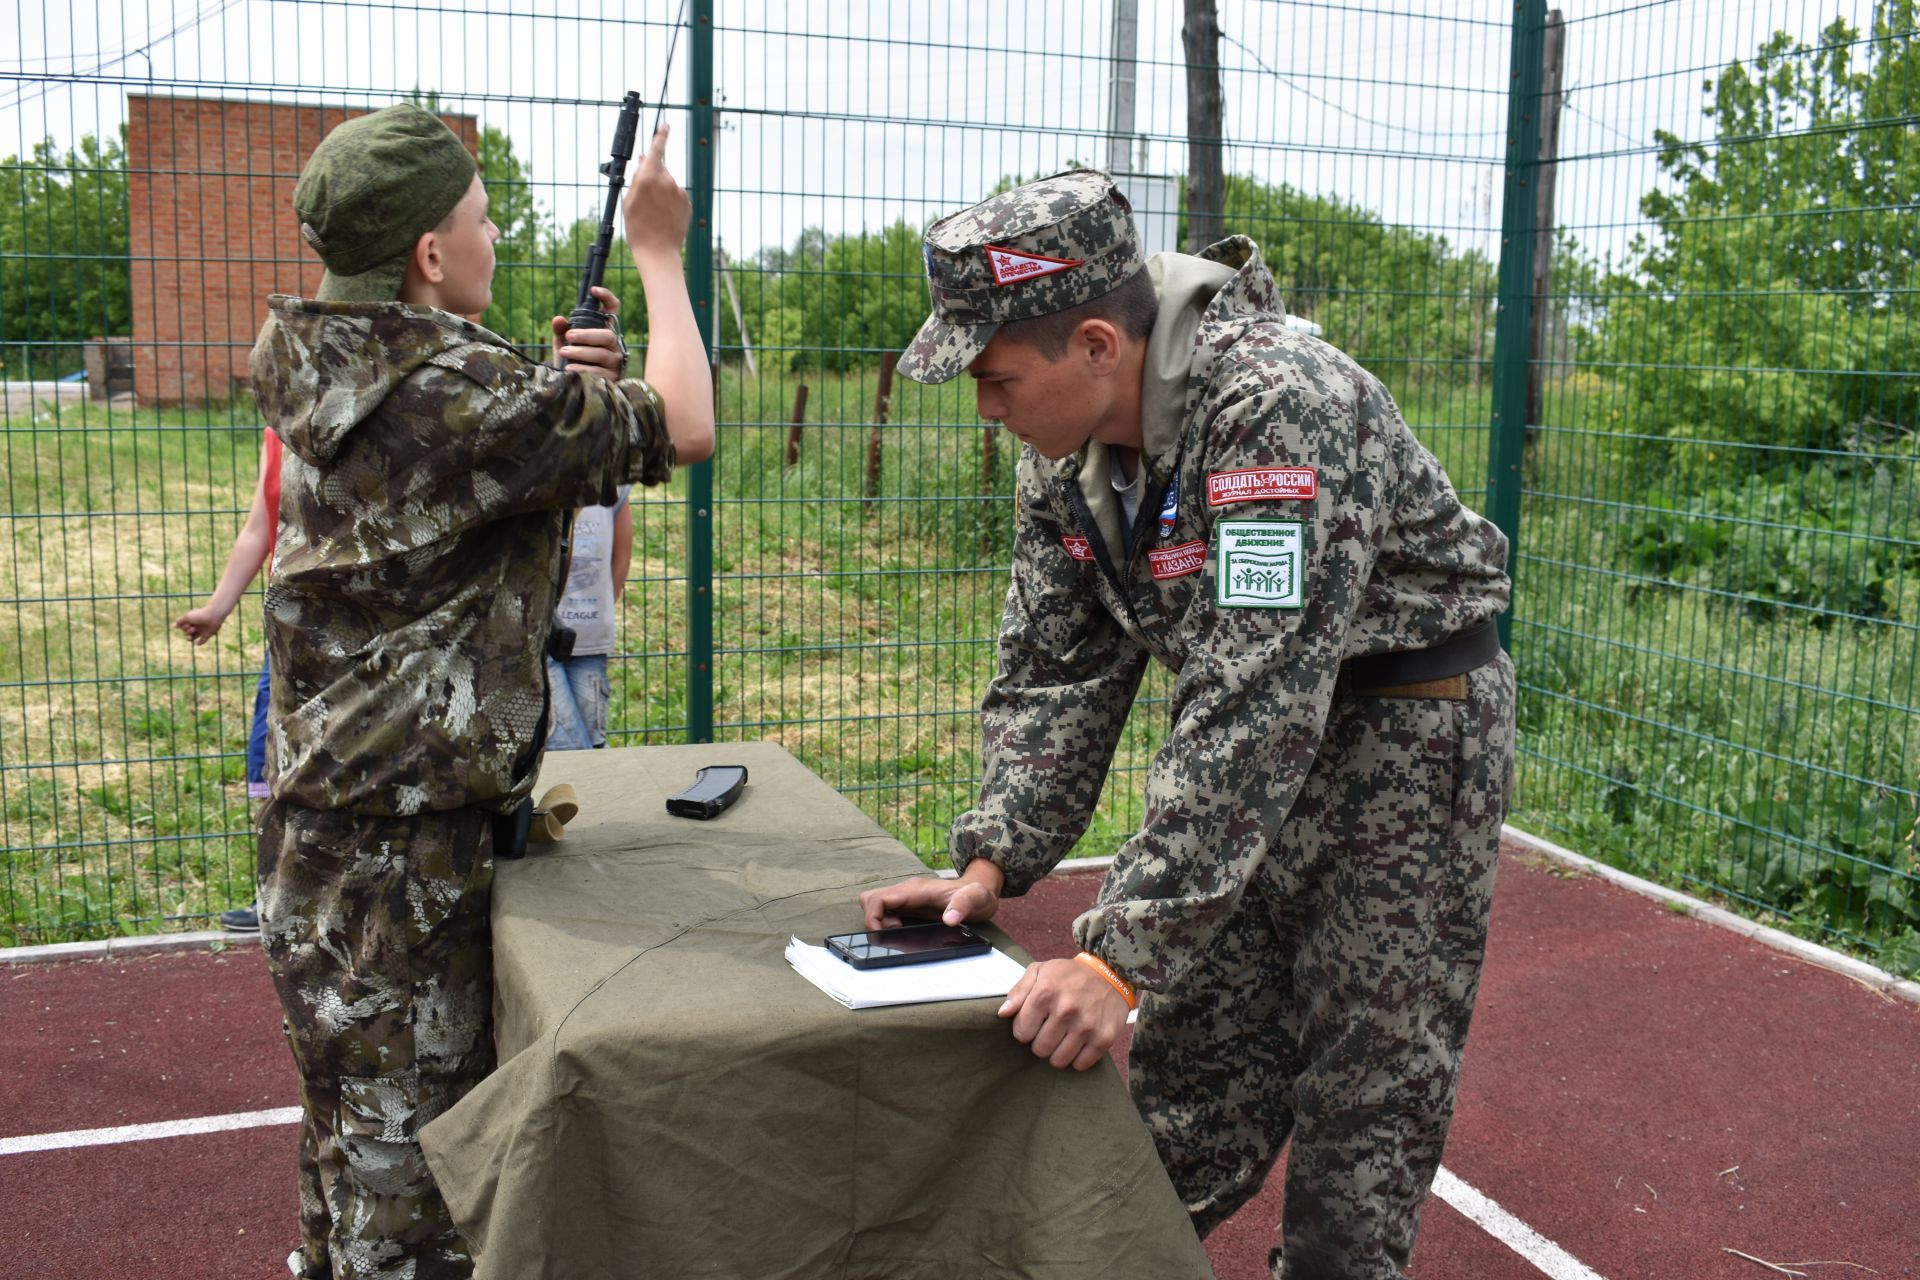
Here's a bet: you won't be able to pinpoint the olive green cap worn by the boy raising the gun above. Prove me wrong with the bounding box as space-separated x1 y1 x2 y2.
294 102 478 301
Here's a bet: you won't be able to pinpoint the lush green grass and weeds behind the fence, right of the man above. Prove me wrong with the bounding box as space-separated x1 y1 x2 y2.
1513 372 1920 973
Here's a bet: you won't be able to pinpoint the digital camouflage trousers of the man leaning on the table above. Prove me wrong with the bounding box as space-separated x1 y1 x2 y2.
1129 654 1513 1280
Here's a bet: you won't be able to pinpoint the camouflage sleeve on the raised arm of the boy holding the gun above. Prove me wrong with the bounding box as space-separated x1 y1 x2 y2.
417 344 674 516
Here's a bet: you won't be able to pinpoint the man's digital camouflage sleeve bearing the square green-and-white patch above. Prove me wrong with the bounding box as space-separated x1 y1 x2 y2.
1073 355 1419 990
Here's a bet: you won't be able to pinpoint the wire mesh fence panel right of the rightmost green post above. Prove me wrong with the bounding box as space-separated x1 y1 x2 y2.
1513 4 1920 971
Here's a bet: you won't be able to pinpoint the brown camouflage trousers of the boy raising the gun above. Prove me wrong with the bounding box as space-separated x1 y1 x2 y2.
259 800 493 1280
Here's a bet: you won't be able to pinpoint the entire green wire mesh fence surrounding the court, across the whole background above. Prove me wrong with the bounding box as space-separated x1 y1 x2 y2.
0 0 1920 965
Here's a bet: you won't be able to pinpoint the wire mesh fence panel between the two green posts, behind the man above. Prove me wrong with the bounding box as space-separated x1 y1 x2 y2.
698 4 1509 867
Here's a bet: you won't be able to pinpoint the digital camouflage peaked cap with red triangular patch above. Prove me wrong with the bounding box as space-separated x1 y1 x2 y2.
899 169 1144 382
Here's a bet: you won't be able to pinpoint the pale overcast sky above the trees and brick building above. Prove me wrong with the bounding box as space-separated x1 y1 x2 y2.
0 0 1872 268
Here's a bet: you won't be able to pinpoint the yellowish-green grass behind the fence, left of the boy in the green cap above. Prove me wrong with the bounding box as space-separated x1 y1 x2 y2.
0 405 261 942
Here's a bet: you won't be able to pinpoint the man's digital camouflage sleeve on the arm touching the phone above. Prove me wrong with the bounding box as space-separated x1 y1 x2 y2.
950 457 1148 896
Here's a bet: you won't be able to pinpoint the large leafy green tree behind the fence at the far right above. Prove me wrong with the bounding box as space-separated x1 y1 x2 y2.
1596 0 1920 640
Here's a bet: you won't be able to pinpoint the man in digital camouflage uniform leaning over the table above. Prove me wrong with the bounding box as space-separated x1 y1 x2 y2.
862 171 1513 1280
